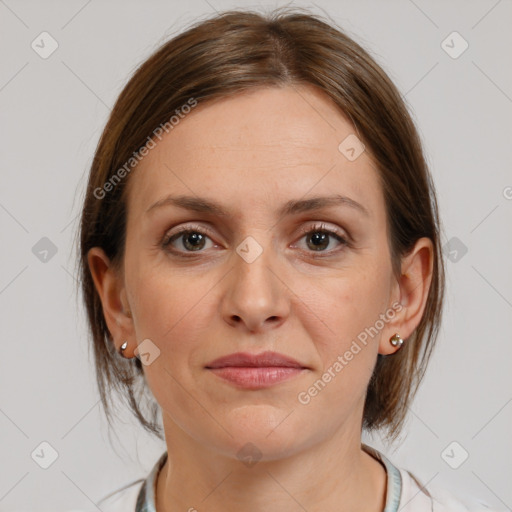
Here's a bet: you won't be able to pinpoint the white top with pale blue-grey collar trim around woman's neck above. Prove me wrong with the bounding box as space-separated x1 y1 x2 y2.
91 444 505 512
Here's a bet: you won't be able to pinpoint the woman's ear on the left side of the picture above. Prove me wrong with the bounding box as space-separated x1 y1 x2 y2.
87 247 135 357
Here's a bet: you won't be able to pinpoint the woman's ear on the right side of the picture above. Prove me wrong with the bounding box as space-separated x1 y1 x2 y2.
379 237 434 355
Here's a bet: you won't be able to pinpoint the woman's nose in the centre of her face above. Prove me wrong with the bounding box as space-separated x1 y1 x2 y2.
221 239 290 333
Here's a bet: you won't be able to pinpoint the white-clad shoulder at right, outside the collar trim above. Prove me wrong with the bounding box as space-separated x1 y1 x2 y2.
399 468 505 512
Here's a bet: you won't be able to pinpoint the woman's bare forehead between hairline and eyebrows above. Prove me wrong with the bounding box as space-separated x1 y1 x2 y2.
128 86 382 217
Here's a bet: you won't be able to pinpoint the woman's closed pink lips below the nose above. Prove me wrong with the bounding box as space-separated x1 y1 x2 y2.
206 351 308 389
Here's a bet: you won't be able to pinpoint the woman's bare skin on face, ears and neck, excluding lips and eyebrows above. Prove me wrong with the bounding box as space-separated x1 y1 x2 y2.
89 86 432 512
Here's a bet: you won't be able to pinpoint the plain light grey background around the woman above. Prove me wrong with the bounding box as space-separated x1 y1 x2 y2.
0 0 512 512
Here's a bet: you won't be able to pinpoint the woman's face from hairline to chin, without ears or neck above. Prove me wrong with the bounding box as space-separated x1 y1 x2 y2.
116 87 407 460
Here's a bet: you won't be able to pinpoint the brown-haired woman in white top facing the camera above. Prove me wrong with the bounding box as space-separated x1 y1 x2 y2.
80 5 502 512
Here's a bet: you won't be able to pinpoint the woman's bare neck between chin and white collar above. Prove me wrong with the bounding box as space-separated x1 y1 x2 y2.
155 420 387 512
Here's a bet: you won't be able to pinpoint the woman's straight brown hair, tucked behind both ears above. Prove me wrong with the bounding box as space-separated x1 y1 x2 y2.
78 8 444 438
